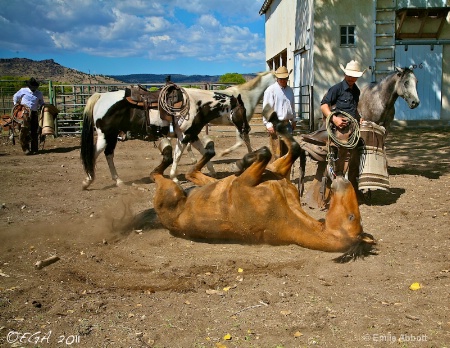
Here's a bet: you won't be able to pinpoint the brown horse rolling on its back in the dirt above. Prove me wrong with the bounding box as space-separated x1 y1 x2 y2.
150 121 375 262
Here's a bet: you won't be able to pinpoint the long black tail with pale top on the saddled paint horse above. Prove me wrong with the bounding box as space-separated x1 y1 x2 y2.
80 93 102 179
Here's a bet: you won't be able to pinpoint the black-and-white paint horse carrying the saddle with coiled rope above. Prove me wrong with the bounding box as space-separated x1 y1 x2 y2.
80 89 242 189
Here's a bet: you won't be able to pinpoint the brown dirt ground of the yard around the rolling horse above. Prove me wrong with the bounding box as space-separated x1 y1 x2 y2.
0 128 450 348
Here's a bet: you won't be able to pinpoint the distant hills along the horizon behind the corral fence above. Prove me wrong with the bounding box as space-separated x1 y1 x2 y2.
0 58 256 84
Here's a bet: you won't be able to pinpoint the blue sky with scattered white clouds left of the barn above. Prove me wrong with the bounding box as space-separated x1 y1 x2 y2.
0 0 266 75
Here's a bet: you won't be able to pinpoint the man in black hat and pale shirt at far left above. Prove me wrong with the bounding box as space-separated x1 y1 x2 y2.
13 77 45 155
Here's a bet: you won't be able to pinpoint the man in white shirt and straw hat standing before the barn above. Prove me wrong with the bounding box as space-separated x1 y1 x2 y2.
263 66 296 160
